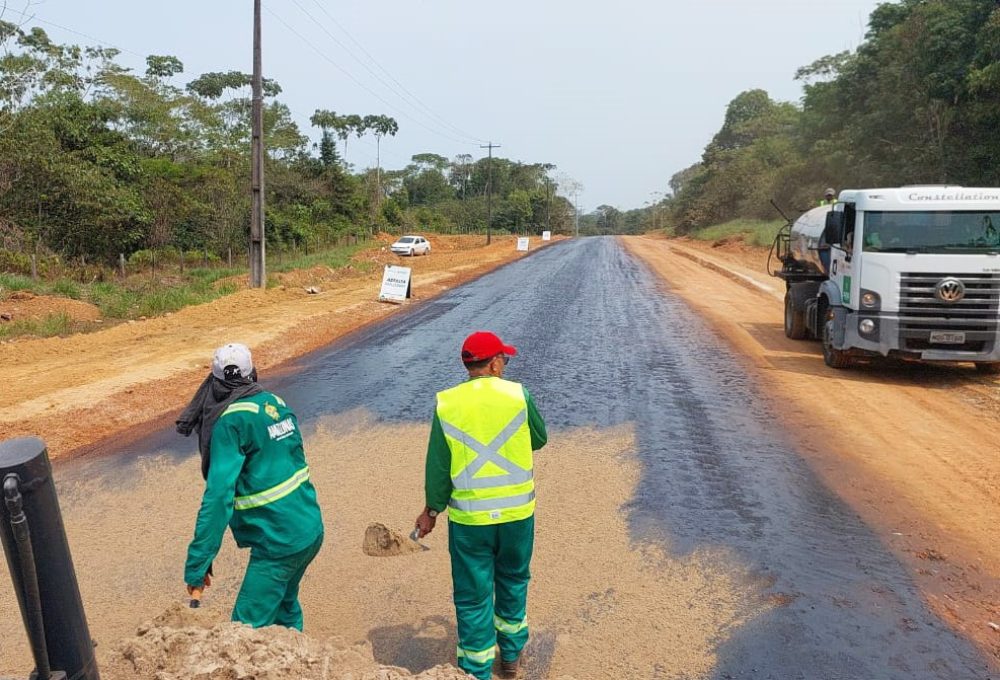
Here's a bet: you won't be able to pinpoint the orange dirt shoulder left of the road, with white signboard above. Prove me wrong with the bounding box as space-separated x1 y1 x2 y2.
0 236 560 458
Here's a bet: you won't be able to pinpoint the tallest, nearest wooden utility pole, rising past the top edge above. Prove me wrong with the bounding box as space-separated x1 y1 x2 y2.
250 0 267 288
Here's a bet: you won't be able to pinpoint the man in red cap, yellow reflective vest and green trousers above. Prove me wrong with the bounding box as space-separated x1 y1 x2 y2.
416 332 547 680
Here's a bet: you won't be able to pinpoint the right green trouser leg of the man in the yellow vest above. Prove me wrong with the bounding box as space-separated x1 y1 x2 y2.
493 515 535 661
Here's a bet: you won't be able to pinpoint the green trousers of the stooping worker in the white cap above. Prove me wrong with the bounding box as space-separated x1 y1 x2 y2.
233 534 323 630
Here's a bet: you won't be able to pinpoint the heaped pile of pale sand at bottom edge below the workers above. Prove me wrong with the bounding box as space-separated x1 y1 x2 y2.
101 604 469 680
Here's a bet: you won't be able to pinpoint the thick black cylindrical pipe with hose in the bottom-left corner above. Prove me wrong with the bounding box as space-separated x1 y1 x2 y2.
0 437 100 680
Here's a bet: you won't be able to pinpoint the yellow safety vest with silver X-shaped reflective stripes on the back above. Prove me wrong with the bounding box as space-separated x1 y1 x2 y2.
437 378 535 525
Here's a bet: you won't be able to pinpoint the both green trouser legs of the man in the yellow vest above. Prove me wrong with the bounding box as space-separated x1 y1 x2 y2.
448 516 535 680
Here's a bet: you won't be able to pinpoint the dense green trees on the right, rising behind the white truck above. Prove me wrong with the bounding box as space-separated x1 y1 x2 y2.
581 0 1000 235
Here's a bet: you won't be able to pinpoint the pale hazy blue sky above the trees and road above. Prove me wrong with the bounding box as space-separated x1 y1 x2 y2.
7 0 879 209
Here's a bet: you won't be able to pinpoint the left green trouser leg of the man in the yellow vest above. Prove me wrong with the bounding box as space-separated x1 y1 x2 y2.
448 523 497 680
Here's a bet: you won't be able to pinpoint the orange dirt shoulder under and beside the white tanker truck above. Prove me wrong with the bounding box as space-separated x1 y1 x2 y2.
624 237 1000 663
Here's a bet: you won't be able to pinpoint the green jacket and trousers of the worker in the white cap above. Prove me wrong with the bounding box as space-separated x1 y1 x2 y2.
184 392 323 630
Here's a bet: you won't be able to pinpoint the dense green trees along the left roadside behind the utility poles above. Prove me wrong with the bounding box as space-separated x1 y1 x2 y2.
0 10 571 278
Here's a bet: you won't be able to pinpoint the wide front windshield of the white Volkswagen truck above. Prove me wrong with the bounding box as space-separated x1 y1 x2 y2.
863 211 1000 253
